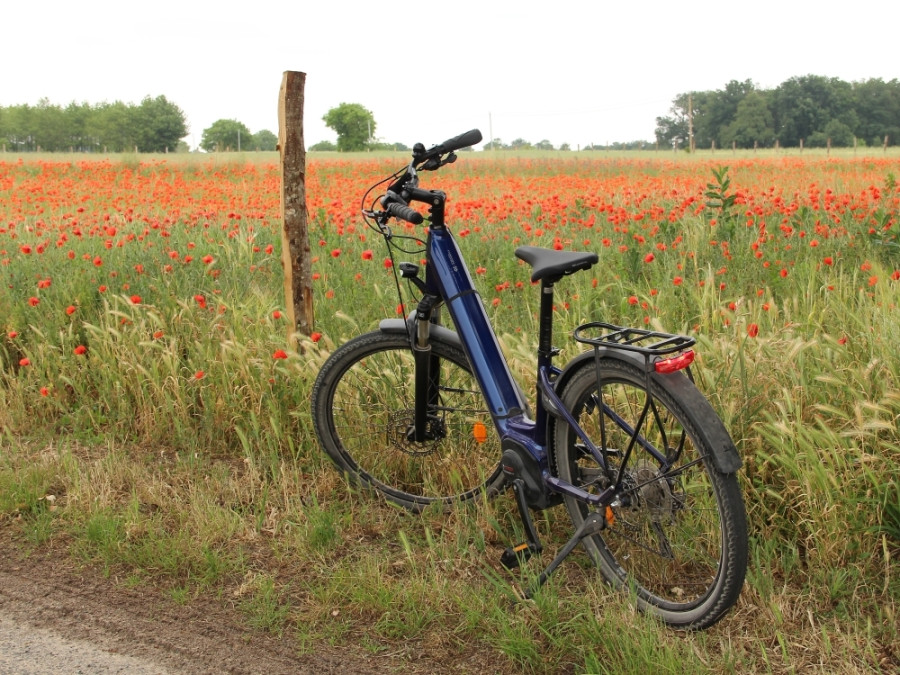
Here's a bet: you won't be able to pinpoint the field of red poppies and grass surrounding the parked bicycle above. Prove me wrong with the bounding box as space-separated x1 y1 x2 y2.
0 152 900 672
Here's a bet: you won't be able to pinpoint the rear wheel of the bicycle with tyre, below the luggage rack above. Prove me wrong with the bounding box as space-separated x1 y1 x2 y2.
553 358 747 629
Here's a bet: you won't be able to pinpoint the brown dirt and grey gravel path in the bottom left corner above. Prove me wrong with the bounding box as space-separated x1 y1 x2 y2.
0 525 444 675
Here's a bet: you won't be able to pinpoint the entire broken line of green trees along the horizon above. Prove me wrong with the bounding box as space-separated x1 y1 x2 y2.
7 75 900 152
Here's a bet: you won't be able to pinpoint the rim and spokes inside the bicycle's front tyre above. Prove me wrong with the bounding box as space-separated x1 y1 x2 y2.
329 345 499 504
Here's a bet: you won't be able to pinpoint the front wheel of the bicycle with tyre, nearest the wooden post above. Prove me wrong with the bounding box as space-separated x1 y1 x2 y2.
312 331 502 510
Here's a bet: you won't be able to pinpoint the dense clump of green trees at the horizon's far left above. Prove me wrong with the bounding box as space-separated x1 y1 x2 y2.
0 96 188 152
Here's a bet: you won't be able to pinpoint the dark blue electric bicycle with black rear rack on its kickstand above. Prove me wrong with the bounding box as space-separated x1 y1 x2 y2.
312 129 747 629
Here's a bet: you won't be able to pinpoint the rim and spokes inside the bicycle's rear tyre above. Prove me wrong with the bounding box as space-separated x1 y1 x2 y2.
561 377 723 611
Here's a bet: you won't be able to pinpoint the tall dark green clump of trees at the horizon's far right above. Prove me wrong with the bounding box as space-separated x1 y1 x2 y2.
656 75 900 148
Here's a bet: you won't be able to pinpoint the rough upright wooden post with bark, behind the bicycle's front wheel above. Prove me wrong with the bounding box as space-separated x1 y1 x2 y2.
278 70 313 345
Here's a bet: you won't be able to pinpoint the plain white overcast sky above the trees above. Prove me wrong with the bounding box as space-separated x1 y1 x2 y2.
0 0 900 149
